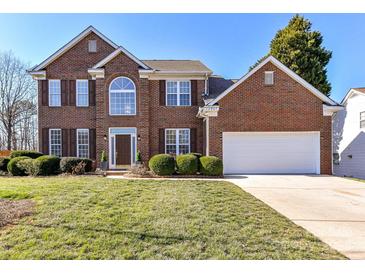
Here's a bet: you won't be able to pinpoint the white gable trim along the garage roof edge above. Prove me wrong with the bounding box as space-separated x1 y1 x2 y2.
208 56 338 106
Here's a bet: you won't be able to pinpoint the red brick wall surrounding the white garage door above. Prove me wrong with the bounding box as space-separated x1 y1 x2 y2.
209 63 332 174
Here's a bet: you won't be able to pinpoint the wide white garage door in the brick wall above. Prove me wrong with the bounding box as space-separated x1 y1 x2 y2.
223 132 320 174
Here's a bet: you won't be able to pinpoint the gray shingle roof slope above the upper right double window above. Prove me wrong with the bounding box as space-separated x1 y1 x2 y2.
141 60 212 73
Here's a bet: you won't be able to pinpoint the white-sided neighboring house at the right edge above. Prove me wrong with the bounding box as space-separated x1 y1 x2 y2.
333 88 365 179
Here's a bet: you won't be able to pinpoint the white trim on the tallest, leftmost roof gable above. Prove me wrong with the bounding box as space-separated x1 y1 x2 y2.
32 26 118 71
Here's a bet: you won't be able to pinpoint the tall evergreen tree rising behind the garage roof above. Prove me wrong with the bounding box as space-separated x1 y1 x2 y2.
252 14 332 96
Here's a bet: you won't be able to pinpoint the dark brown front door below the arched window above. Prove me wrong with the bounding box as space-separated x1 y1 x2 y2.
115 135 131 168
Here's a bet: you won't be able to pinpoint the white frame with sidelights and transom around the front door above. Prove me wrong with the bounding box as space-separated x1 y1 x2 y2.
108 127 137 169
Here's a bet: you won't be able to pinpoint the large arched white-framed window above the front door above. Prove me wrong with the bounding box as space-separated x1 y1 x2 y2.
109 77 136 115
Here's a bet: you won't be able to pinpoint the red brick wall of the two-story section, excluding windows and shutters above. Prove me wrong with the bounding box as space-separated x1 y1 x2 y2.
38 34 205 165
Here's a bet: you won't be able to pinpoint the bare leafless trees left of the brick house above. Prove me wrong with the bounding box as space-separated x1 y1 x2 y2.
0 52 37 150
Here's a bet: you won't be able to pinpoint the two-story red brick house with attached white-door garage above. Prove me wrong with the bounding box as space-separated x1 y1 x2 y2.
29 27 341 174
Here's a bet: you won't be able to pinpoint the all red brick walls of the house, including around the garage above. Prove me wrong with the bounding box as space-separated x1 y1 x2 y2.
38 28 332 174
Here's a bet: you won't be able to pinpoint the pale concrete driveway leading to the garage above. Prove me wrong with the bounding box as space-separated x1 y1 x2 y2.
226 175 365 259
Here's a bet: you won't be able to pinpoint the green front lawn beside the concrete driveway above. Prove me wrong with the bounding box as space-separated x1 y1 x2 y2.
0 177 344 259
